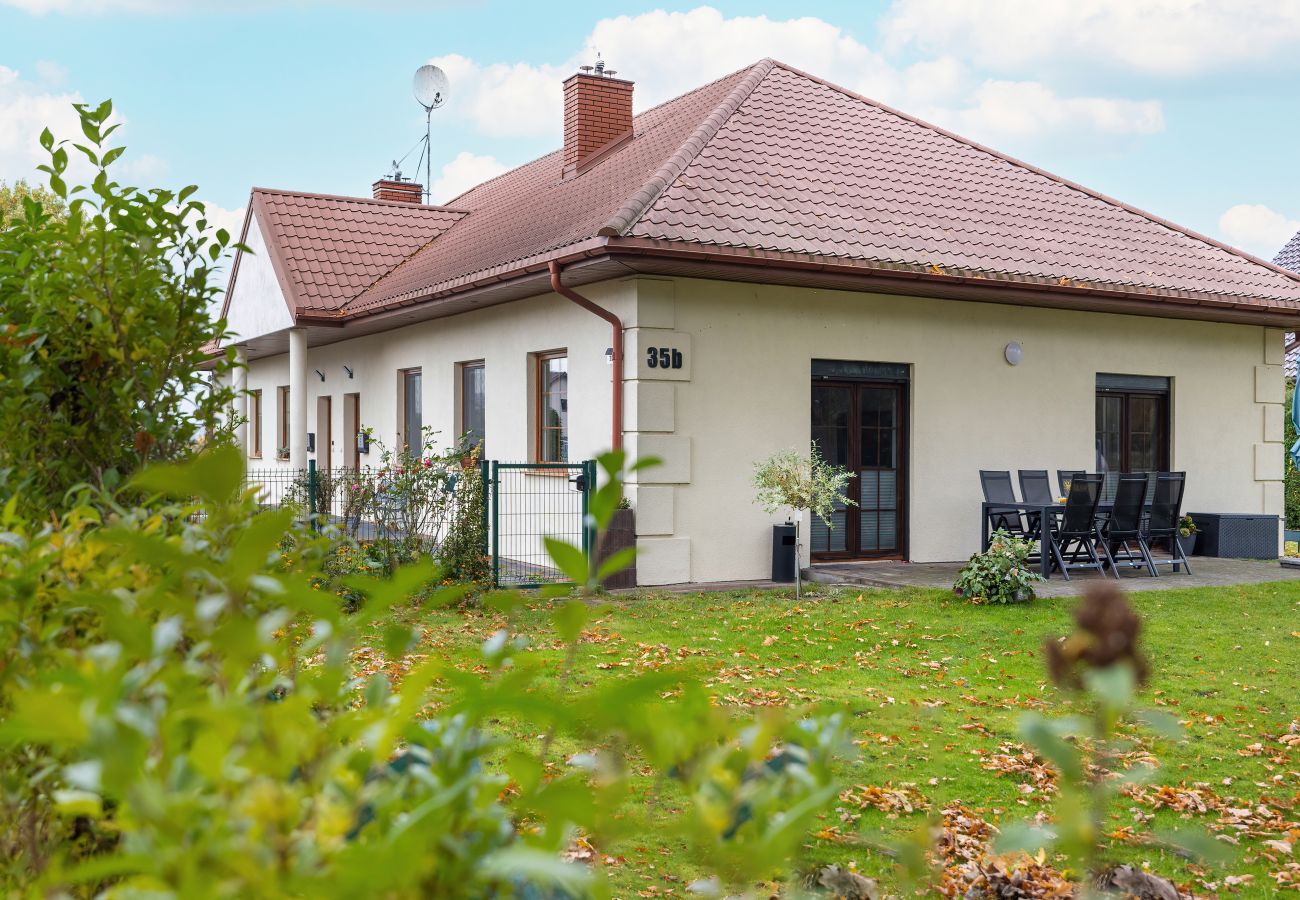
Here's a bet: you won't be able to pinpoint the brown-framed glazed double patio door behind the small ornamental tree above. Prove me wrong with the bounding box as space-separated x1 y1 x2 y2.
810 381 907 559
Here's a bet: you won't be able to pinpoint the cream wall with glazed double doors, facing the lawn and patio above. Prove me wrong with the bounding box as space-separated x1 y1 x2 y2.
628 278 1282 581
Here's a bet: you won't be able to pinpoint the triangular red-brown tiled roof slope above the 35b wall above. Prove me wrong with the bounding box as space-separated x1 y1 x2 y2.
627 65 1300 300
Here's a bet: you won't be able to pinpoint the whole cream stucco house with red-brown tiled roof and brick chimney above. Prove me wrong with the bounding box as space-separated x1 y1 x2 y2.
218 60 1300 584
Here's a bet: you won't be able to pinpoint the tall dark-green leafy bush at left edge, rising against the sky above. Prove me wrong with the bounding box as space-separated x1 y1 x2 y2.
0 101 234 516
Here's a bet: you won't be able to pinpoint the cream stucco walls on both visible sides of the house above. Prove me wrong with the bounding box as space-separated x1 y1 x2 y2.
241 276 1282 584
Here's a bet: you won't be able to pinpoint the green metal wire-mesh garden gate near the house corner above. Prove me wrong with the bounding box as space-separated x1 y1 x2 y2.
482 459 595 588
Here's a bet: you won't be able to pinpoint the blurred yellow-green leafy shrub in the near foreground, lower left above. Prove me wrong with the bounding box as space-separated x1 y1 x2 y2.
0 447 845 897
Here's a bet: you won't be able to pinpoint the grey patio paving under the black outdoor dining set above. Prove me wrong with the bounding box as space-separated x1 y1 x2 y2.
805 557 1300 597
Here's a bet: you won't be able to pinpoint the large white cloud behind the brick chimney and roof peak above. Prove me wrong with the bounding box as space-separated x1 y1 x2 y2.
430 0 1164 148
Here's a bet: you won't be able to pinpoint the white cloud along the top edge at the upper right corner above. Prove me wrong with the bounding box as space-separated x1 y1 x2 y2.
880 0 1300 75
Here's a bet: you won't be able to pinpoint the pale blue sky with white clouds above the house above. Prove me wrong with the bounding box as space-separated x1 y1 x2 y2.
0 0 1300 256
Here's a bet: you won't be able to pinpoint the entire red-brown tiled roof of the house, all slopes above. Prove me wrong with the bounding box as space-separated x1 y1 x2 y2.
239 60 1300 317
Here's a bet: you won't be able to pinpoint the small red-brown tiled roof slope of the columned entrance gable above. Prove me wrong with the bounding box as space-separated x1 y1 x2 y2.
245 187 465 312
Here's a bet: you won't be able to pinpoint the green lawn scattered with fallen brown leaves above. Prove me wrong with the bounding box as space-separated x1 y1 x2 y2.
364 583 1300 896
